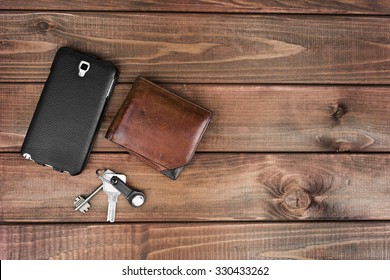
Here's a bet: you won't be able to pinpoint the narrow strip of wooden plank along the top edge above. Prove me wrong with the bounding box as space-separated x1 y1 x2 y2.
0 0 390 15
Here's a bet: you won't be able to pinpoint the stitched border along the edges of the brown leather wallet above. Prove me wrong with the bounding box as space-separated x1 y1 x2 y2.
107 77 213 169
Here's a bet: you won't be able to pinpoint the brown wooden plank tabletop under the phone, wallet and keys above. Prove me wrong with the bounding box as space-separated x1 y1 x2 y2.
0 0 390 259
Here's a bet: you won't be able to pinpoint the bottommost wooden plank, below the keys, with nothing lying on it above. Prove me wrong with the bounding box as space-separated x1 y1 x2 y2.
0 222 390 260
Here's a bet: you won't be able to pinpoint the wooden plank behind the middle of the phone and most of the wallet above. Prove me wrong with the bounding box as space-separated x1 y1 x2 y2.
0 84 390 152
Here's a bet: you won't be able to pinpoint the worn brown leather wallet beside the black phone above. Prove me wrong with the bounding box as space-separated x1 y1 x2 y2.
106 77 212 180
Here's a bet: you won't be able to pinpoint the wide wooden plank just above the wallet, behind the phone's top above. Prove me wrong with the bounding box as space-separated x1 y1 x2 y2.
0 12 390 84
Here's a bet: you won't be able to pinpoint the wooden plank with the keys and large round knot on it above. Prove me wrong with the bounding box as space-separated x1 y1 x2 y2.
0 153 390 222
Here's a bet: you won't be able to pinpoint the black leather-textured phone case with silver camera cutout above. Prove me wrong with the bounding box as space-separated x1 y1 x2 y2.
21 47 117 175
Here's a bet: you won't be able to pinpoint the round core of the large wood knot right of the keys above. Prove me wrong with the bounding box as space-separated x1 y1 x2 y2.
282 188 312 213
